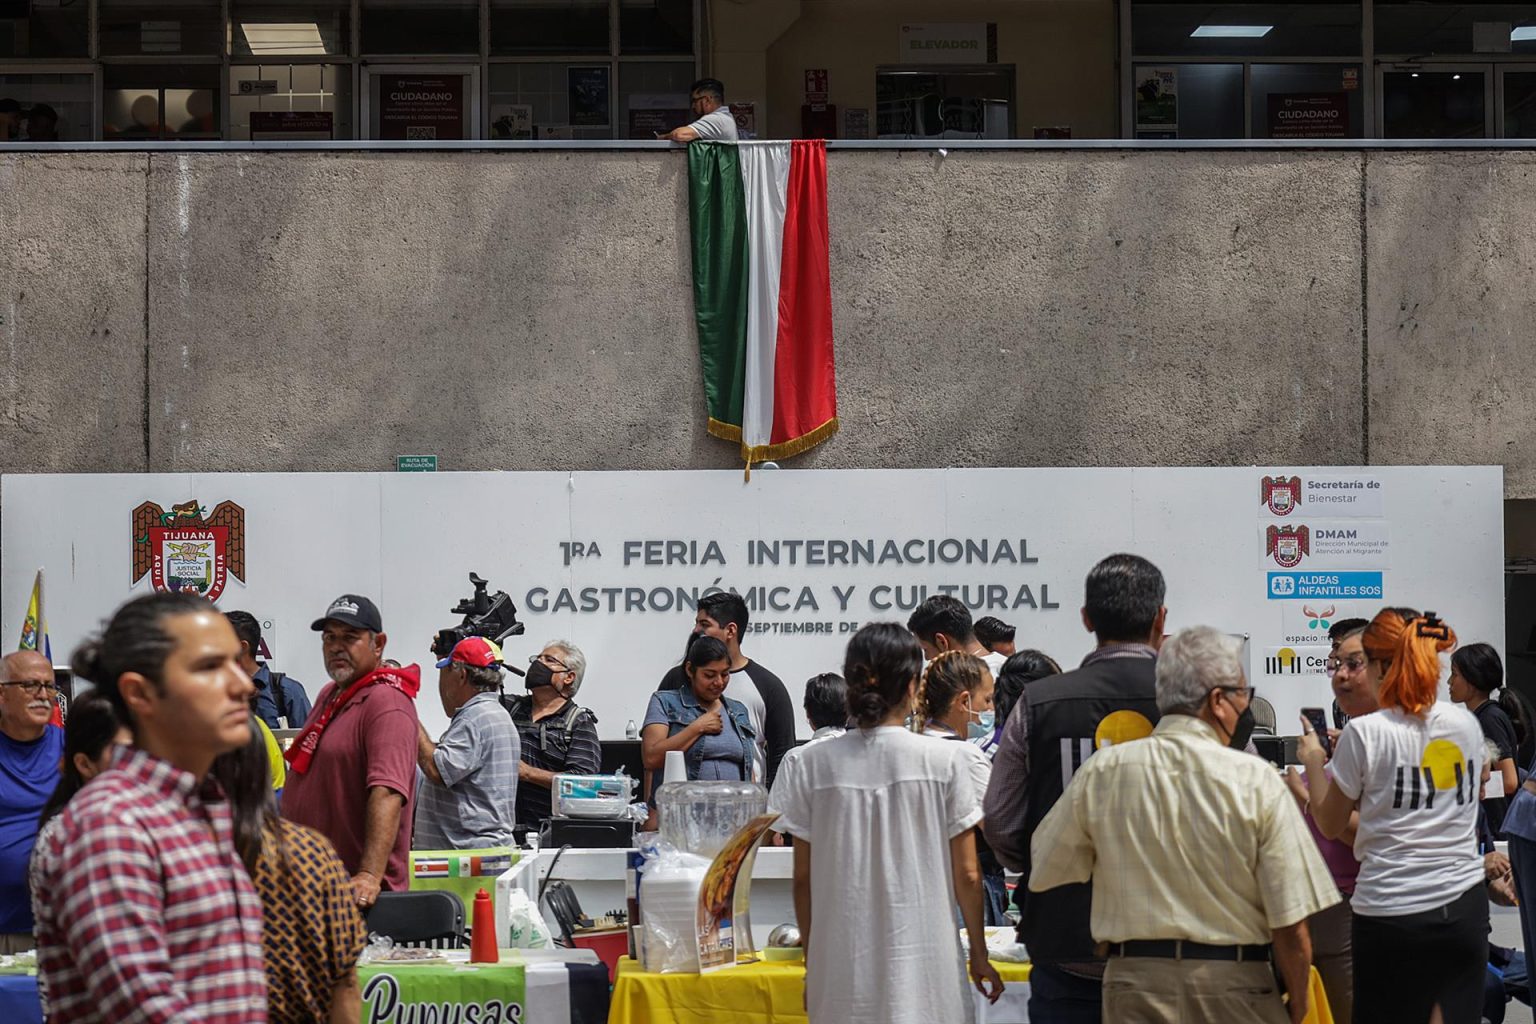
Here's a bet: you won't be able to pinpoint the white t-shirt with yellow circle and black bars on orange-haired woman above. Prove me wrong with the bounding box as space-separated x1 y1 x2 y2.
1329 702 1484 917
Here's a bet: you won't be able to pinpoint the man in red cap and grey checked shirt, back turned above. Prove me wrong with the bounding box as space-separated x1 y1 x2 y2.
413 637 521 851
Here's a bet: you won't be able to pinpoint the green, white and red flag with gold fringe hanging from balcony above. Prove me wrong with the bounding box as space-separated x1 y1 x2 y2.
688 140 837 470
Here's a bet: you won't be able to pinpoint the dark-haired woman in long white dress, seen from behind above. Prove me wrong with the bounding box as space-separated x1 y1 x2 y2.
776 622 1003 1024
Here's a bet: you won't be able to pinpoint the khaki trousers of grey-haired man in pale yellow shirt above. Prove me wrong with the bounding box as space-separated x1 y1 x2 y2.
1104 956 1290 1024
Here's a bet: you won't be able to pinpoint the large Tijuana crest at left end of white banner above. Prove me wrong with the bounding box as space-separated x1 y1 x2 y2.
132 499 246 600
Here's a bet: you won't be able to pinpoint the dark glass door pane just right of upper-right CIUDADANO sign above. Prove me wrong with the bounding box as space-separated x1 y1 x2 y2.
1376 64 1495 138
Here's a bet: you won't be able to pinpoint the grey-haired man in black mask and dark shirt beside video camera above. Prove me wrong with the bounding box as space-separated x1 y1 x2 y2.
502 640 602 829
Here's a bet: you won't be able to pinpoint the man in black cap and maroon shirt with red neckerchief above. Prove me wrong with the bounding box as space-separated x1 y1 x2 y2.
283 594 421 909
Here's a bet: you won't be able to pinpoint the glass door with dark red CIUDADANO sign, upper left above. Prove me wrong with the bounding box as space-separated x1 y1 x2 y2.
362 64 481 143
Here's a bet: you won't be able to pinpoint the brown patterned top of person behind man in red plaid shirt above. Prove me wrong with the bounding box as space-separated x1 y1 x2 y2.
250 818 367 1024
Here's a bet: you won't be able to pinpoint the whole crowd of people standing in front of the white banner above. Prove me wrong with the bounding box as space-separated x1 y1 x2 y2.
0 554 1536 1024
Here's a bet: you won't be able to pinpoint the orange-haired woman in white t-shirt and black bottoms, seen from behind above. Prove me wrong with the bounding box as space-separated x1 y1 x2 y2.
1299 608 1488 1024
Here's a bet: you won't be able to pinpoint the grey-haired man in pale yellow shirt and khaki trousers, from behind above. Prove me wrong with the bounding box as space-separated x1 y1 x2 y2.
1029 626 1339 1024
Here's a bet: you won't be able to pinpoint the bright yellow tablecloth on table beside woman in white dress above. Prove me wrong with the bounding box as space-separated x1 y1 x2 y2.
608 956 1333 1024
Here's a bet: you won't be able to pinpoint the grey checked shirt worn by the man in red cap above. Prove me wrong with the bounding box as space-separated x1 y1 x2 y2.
412 692 521 851
